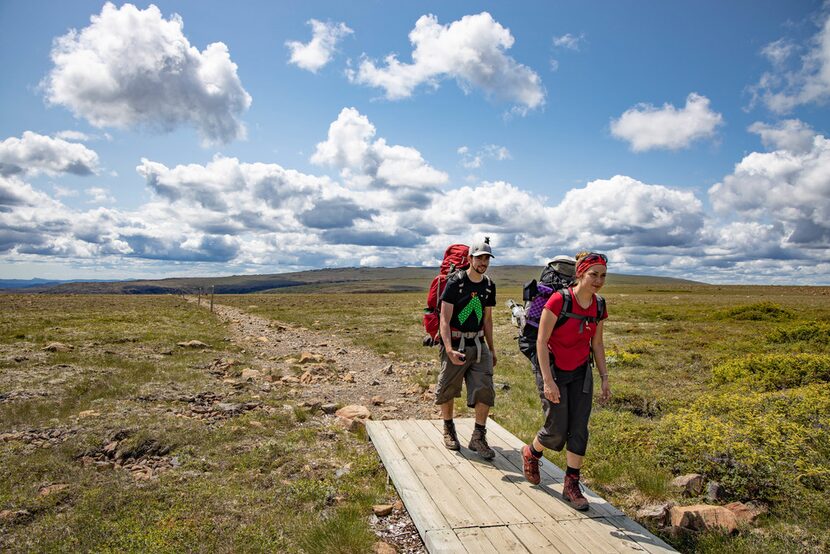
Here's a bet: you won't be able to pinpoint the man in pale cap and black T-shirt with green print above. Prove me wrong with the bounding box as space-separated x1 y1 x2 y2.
435 238 496 460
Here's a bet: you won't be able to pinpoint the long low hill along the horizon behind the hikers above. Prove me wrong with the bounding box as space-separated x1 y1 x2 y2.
0 265 702 294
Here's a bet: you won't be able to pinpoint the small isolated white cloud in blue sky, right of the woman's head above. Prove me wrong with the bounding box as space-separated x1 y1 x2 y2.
611 92 723 152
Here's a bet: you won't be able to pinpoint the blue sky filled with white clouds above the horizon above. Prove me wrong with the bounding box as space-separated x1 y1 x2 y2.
0 0 830 284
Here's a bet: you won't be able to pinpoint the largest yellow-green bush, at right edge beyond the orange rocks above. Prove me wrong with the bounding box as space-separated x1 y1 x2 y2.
656 383 830 504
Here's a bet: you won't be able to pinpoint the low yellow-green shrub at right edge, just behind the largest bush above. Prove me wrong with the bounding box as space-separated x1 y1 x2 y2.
712 354 830 391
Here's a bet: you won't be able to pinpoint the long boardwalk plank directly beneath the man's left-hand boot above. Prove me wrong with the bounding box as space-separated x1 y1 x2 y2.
416 420 528 525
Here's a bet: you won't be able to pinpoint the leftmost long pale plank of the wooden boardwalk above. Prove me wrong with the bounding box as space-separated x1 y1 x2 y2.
366 421 450 541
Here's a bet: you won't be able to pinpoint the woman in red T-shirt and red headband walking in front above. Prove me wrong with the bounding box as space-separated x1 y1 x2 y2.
522 252 611 511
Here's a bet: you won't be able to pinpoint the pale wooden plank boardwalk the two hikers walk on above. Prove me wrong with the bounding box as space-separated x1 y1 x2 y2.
366 419 675 554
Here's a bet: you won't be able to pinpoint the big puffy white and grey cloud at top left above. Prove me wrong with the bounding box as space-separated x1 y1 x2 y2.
42 2 251 144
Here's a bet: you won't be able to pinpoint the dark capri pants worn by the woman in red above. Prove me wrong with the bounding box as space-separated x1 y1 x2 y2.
530 352 594 456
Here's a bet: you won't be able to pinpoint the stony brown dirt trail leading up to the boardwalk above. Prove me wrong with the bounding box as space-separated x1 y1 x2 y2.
212 305 440 553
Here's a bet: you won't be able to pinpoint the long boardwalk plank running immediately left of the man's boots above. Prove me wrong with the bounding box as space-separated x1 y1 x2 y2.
400 419 504 527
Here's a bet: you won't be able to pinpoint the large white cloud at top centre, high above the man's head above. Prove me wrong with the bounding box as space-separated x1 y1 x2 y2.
347 12 545 113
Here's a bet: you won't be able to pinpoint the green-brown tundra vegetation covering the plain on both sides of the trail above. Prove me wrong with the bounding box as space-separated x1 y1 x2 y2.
0 280 830 553
